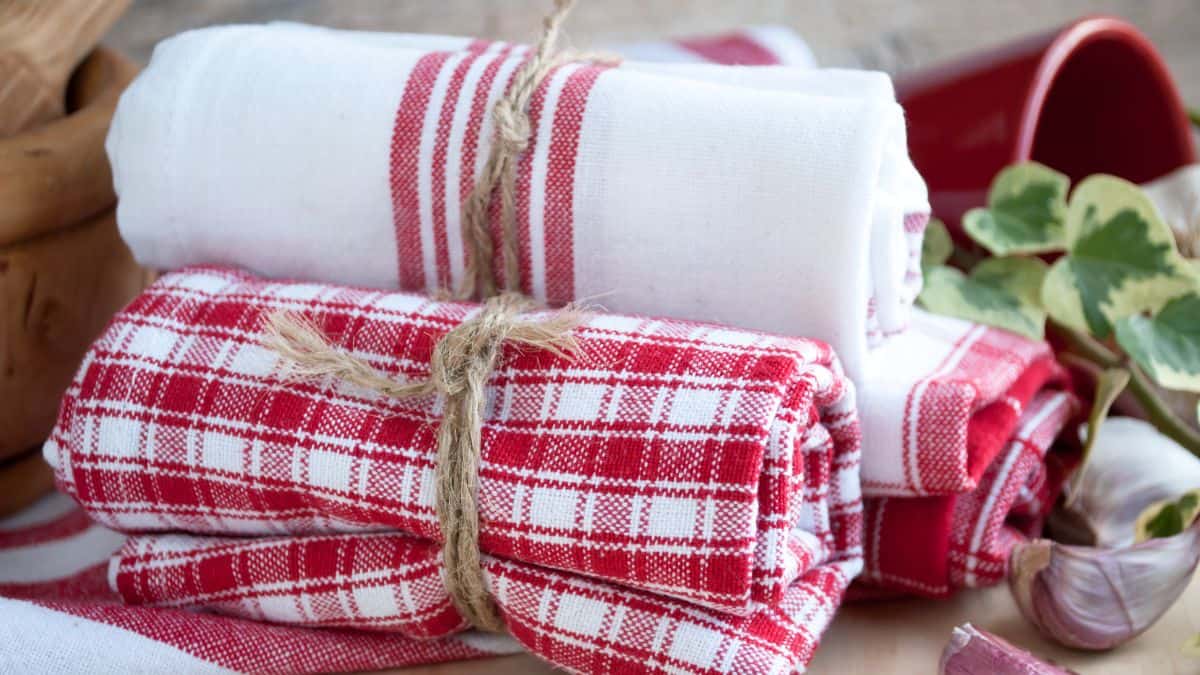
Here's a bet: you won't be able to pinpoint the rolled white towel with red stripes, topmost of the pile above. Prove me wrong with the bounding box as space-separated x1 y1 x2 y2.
108 25 929 376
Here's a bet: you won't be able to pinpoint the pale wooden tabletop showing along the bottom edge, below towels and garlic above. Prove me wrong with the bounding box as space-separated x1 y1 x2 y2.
381 571 1200 675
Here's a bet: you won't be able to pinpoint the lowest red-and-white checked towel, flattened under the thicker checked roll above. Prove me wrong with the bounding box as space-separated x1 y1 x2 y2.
112 534 859 674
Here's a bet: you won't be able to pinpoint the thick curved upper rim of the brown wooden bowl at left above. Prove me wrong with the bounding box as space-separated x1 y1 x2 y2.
0 47 137 246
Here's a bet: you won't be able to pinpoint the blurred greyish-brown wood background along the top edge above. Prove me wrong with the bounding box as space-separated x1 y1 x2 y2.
109 0 1200 104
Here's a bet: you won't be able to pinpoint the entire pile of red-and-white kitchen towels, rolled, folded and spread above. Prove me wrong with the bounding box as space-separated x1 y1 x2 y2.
0 18 1076 673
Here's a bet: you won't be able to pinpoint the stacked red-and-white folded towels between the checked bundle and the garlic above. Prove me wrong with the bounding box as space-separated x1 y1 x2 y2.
859 310 1079 596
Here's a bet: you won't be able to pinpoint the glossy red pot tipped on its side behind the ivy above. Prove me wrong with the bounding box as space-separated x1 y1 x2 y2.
896 16 1195 231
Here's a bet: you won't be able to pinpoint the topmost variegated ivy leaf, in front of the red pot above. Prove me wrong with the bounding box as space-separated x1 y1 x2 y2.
962 162 1070 256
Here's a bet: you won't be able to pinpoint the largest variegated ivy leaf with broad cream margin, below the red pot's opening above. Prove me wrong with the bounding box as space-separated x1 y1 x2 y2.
1042 175 1195 338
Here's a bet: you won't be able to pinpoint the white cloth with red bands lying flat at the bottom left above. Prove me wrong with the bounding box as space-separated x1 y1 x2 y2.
0 494 520 675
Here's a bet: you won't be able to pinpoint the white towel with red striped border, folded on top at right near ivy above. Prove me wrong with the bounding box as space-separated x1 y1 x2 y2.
858 310 1066 497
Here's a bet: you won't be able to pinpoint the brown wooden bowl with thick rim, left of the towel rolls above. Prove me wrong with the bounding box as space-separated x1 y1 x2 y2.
0 49 151 461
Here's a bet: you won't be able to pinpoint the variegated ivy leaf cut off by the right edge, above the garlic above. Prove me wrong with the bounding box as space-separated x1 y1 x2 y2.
1116 293 1200 392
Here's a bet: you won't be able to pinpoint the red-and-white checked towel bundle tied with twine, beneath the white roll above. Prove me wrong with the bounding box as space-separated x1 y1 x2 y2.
46 269 862 673
